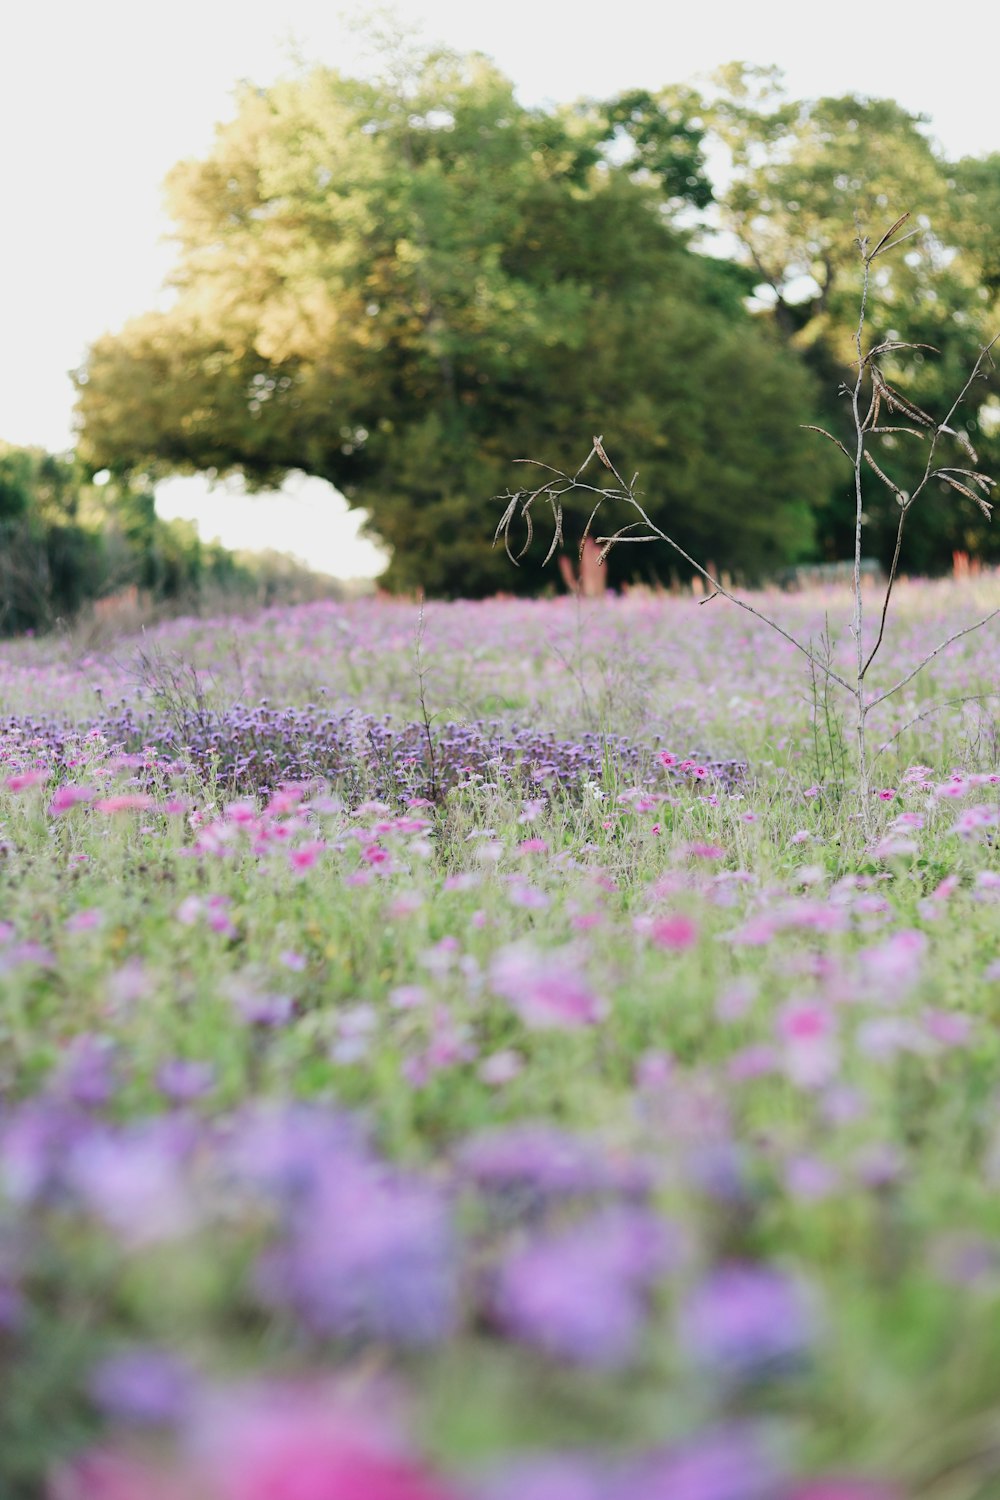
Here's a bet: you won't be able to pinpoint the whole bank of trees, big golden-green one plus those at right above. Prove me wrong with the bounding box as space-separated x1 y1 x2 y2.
64 51 1000 596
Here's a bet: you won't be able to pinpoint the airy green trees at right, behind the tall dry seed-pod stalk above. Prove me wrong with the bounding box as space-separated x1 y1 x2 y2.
695 65 1000 573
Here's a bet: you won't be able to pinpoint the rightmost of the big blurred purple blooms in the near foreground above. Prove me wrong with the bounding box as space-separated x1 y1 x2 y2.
679 1263 816 1379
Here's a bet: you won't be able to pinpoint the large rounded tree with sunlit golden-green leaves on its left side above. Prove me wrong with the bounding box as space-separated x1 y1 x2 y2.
78 53 828 594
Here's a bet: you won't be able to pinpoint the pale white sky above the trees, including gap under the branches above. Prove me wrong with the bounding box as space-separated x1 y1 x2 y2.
0 0 1000 576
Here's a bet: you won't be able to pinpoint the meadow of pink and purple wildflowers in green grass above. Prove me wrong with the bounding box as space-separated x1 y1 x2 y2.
0 575 1000 1500
